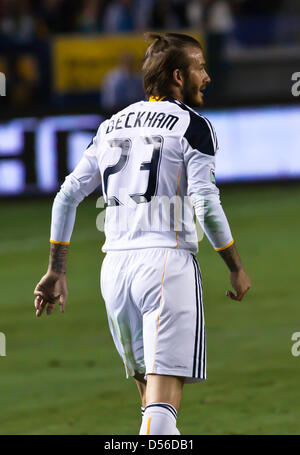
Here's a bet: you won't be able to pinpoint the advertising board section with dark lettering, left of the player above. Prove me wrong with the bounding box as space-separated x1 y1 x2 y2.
0 115 103 195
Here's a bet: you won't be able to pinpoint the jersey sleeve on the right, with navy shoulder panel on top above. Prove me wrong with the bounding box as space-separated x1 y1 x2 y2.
183 111 233 251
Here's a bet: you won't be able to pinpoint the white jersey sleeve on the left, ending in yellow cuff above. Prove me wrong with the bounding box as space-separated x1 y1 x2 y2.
50 132 101 245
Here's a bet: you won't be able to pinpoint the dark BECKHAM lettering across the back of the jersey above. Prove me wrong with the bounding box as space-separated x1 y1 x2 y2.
106 111 179 134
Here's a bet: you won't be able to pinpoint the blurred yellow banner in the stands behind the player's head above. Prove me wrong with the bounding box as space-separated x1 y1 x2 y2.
52 31 202 94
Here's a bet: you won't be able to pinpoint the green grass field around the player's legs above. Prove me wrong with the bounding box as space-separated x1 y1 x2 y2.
0 184 300 435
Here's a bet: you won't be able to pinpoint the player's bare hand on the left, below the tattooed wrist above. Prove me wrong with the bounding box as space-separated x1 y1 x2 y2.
33 270 68 317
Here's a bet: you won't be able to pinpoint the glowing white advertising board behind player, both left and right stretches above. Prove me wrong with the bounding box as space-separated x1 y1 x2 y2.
0 106 300 196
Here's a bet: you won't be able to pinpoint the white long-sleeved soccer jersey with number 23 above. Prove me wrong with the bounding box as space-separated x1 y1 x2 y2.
51 97 233 252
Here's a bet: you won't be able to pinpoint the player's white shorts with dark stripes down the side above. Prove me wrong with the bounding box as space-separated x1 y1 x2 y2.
101 248 206 383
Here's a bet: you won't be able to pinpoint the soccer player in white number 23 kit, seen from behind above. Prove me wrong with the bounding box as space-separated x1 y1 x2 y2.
34 33 250 435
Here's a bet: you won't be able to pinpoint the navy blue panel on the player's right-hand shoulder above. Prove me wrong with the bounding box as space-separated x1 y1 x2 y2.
178 103 216 156
